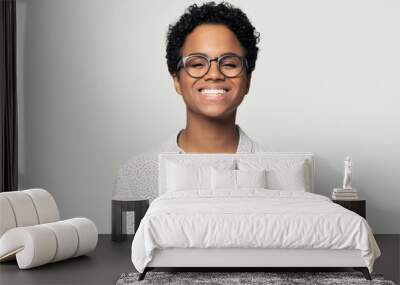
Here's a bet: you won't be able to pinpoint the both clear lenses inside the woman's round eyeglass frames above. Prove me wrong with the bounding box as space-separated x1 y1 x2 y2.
184 55 242 77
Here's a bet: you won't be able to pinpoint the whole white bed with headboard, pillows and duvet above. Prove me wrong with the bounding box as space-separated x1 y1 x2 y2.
132 153 380 279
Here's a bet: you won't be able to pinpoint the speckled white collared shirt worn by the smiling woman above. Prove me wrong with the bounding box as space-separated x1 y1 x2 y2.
112 125 269 201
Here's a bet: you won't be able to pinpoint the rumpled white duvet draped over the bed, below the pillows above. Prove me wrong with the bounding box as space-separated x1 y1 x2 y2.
132 189 380 272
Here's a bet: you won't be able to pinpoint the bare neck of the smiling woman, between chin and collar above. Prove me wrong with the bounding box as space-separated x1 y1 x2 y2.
178 115 240 153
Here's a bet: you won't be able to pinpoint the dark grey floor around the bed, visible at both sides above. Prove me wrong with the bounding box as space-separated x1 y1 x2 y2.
0 235 400 285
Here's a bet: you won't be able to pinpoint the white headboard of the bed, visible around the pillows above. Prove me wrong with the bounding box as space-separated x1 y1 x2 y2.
158 152 315 195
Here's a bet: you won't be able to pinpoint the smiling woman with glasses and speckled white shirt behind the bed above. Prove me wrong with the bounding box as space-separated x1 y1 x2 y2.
113 2 269 216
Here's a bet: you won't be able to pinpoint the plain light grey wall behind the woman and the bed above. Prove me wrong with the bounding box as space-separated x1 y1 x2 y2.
17 0 400 234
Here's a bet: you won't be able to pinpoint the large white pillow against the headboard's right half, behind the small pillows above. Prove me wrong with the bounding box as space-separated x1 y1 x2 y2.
238 159 311 191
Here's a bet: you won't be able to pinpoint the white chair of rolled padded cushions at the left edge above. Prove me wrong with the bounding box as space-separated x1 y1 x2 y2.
0 189 98 269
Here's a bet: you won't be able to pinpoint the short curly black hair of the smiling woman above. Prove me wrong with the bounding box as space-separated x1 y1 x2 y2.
166 2 260 75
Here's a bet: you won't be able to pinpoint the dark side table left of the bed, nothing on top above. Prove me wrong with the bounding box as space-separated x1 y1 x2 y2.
111 200 149 241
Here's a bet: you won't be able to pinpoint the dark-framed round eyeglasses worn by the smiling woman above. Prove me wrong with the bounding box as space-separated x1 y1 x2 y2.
177 54 247 78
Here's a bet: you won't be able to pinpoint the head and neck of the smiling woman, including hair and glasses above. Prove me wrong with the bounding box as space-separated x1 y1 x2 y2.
167 2 259 153
